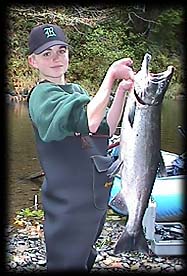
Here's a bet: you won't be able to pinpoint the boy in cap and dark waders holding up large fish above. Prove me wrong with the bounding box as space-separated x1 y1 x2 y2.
28 24 133 272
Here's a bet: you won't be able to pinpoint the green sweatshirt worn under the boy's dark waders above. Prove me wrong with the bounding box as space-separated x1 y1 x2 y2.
29 82 109 142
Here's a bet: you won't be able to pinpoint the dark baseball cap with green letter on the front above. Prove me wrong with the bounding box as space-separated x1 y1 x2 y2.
29 24 68 55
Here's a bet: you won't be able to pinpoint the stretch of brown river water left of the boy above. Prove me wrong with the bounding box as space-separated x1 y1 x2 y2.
7 103 40 224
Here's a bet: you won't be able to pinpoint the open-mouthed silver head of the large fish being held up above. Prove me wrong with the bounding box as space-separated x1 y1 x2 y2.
134 53 174 105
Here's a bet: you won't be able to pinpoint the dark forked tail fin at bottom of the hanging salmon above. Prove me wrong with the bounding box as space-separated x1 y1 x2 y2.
114 228 149 254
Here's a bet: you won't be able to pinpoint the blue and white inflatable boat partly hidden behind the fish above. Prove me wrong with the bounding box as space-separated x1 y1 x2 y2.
108 146 186 222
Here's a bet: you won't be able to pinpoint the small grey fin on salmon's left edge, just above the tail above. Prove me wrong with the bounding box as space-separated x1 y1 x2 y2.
108 192 128 216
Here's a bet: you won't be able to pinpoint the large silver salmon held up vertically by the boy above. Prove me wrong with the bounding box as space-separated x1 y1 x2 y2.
114 53 174 254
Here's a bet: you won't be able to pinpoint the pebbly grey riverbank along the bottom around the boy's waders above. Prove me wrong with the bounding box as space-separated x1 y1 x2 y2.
6 220 186 273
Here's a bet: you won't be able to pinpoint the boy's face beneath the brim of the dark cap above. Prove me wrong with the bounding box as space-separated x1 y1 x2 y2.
28 45 69 79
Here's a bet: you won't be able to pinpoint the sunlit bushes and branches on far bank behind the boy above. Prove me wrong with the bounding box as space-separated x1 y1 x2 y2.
6 5 184 97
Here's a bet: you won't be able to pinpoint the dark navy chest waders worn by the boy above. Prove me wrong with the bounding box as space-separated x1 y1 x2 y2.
34 128 111 272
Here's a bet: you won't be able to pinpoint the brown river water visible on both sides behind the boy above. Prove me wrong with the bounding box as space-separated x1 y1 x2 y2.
6 100 186 223
